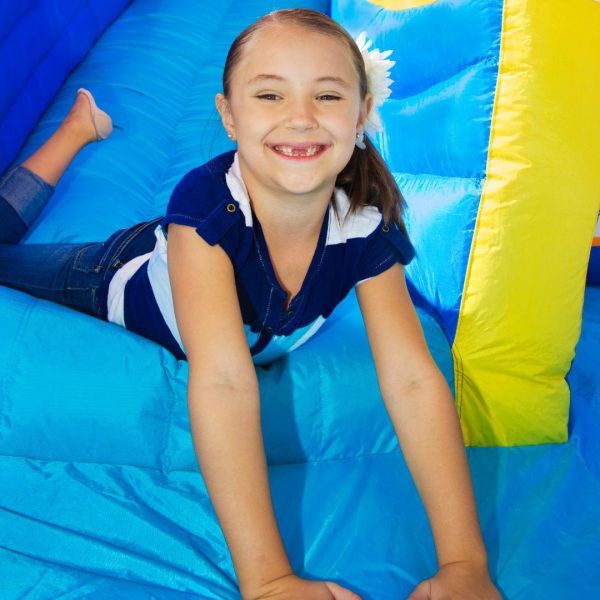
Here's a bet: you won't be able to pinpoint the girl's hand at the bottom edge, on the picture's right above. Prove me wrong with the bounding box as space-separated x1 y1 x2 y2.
407 561 502 600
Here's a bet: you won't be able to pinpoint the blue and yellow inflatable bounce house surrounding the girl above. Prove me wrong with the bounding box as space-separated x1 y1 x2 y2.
0 0 600 600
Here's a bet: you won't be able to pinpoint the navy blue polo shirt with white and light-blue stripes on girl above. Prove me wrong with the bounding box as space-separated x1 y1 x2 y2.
108 152 414 364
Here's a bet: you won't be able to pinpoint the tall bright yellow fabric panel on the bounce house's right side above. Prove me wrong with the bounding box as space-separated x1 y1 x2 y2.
453 0 600 445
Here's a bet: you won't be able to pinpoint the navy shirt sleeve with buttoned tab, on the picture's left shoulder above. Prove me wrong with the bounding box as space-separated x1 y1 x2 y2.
160 169 241 264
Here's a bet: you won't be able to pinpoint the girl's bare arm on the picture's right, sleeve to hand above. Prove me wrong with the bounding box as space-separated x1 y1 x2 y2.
357 264 499 600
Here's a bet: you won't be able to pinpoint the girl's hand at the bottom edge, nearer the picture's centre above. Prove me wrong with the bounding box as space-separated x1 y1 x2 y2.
244 575 361 600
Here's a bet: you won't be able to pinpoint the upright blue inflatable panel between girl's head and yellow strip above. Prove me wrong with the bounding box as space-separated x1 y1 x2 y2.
332 0 503 343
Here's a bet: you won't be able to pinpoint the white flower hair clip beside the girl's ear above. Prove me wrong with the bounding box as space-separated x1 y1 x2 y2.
356 31 396 150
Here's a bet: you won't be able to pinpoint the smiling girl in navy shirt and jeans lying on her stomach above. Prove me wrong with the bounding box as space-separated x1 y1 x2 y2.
0 10 499 600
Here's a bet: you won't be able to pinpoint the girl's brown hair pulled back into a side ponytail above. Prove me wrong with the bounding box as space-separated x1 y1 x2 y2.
223 8 406 234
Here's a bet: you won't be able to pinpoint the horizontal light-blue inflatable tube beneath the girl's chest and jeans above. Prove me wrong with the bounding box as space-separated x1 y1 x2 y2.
0 288 452 472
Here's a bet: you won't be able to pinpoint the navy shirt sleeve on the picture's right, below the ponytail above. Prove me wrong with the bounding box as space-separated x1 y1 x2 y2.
355 219 415 285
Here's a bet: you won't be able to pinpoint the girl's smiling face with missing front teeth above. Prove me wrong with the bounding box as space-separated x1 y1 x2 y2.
216 24 371 204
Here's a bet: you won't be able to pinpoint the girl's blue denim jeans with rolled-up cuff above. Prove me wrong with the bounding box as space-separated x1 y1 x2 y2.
0 166 161 320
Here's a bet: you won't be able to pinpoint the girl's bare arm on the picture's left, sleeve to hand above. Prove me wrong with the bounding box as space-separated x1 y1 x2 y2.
168 224 360 600
